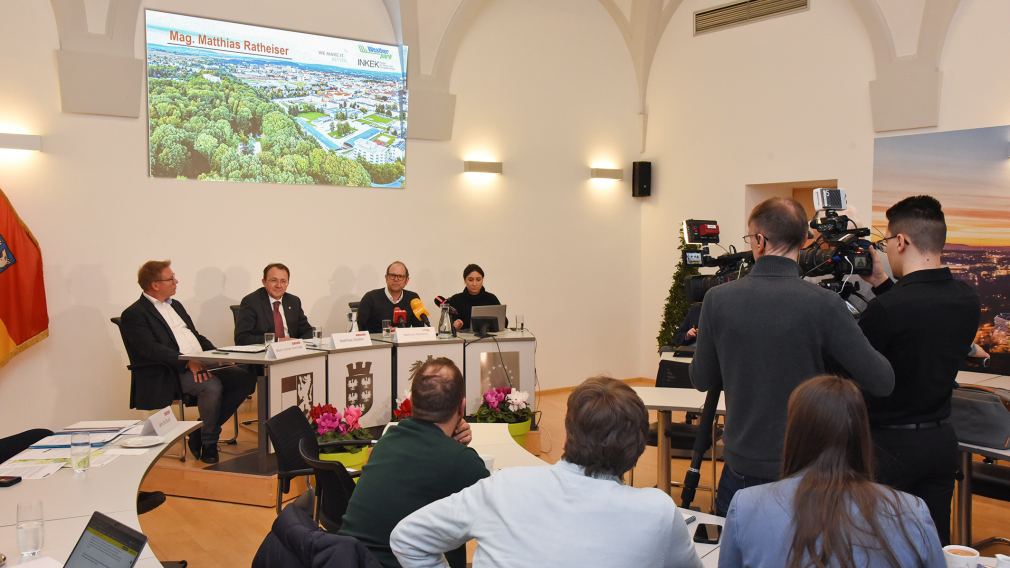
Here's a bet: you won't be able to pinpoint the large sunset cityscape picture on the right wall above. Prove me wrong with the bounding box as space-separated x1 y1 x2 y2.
873 126 1010 374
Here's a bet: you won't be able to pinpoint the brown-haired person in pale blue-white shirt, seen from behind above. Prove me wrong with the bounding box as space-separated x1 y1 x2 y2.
390 377 702 568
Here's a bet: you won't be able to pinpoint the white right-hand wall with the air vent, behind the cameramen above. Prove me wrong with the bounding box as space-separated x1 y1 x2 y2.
639 0 1010 374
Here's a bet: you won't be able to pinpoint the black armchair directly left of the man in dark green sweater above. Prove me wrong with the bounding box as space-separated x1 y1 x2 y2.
298 436 375 533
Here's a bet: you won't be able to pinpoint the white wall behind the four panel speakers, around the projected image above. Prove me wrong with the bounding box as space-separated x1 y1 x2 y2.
0 0 640 436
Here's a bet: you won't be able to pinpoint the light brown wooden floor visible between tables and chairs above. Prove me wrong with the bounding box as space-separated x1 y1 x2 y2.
140 379 1010 568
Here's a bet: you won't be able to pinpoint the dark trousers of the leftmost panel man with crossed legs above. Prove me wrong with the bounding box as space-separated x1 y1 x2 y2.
179 367 256 446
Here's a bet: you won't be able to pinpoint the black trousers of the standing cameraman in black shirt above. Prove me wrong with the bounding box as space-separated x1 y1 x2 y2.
873 423 957 546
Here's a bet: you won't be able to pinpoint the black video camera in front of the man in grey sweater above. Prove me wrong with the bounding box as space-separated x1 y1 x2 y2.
683 219 754 302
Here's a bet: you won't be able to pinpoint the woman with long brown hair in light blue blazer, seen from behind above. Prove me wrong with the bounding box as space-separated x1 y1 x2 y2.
719 375 945 568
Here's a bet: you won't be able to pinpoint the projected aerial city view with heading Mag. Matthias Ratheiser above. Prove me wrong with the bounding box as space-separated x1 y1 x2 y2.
145 10 407 188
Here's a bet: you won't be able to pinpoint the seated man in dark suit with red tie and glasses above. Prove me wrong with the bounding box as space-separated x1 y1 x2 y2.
235 263 312 345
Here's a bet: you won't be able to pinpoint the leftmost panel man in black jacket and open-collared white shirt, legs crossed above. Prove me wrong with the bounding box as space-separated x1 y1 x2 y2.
121 261 256 464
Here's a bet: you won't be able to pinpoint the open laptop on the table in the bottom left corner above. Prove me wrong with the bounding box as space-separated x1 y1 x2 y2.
64 511 147 568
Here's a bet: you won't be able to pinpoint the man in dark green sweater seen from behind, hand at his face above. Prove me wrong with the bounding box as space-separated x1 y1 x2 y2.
340 357 480 568
